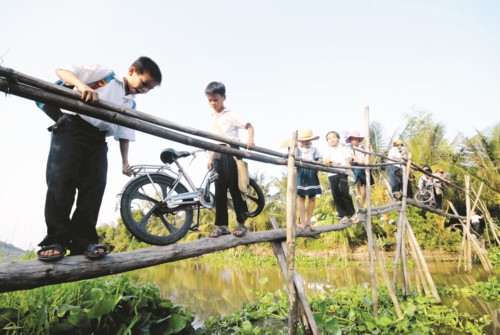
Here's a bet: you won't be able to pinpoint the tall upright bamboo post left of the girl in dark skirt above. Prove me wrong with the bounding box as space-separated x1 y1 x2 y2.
286 131 298 335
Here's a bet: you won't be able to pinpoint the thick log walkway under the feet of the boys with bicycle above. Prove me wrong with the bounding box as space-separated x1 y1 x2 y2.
0 224 349 292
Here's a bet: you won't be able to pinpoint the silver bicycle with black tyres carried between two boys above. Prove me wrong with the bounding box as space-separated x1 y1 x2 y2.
118 148 265 245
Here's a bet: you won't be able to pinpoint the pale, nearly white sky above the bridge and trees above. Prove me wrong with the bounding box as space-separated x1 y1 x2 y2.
0 0 500 248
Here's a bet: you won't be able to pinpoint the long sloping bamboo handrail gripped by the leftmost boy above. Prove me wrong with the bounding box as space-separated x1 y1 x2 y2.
0 66 354 177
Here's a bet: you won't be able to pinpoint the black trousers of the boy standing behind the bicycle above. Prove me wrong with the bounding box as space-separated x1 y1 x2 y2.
213 153 248 226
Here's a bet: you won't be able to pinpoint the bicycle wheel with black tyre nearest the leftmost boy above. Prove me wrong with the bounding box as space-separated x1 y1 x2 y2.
120 174 193 245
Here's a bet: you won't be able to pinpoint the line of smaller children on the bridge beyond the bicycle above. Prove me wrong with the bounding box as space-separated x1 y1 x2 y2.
297 128 454 230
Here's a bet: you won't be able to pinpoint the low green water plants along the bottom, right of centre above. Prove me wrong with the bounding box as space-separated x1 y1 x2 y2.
197 286 491 335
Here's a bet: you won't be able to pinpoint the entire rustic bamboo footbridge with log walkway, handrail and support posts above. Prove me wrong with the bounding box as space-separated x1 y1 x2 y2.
0 66 500 334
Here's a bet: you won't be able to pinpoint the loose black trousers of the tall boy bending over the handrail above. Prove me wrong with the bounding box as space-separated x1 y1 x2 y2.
39 114 108 252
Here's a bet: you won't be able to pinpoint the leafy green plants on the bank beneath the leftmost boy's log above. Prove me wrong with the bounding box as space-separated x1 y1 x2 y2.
0 276 194 334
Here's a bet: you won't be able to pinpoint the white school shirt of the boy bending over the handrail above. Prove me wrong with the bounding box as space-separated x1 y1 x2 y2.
59 64 135 141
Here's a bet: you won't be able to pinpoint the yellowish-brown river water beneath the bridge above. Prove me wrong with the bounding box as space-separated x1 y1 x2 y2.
133 260 500 334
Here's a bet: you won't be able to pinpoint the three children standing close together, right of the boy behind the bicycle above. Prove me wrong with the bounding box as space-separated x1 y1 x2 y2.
297 128 373 231
